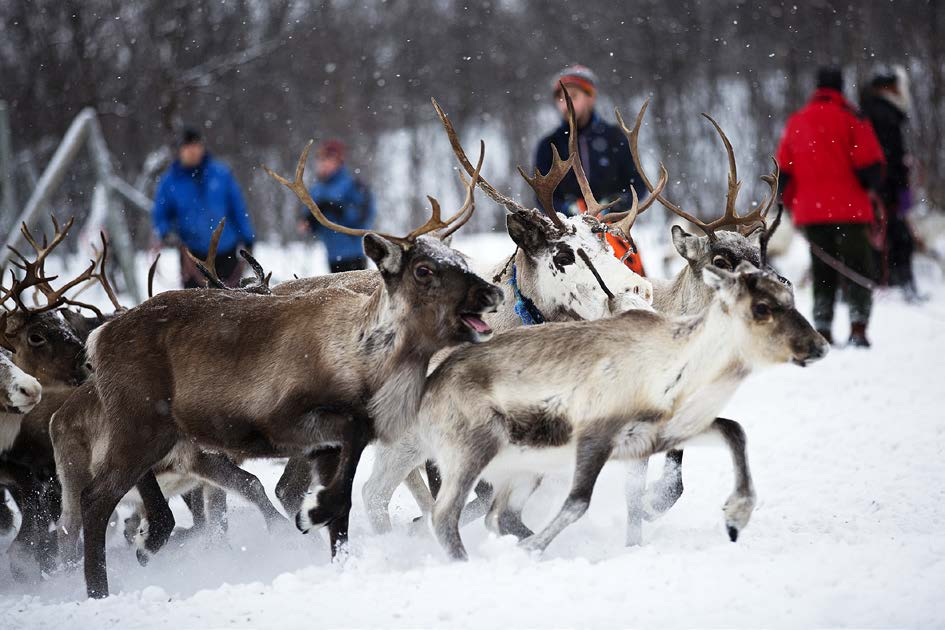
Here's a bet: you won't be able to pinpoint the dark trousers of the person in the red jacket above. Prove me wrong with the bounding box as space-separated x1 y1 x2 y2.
805 223 874 330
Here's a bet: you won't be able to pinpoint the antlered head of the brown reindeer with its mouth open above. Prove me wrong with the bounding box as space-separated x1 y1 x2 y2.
266 142 503 347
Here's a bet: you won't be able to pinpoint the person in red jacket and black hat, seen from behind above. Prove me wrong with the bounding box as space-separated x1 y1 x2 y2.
778 68 884 347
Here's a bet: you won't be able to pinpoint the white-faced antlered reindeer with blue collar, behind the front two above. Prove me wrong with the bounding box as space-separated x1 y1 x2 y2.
274 92 666 531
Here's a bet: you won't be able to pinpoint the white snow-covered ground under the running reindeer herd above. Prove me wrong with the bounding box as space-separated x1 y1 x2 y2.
0 231 945 629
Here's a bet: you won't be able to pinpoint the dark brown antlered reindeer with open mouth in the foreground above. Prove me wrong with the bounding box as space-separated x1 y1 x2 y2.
53 143 502 597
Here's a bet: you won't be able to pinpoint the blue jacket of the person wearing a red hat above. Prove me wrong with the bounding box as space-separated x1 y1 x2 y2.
301 166 377 262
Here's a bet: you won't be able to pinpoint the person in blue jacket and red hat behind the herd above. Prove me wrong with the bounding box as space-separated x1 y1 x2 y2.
299 139 376 273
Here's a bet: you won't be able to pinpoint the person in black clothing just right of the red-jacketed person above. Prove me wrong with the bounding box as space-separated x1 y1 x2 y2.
860 67 918 299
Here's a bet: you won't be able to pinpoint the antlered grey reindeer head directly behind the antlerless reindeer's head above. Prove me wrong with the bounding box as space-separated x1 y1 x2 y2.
615 100 790 286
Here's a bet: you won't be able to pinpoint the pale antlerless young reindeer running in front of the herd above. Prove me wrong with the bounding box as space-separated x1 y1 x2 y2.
417 263 828 559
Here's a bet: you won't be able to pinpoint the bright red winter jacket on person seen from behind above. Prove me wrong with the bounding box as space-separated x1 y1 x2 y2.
778 88 885 225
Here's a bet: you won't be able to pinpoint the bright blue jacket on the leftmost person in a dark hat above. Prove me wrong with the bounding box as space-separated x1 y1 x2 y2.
151 154 256 257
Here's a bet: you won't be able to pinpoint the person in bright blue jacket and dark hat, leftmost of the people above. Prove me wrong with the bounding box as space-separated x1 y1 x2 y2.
151 128 255 289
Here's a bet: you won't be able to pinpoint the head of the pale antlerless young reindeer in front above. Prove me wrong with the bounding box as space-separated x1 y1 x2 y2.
703 262 830 367
